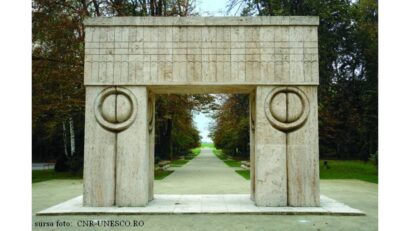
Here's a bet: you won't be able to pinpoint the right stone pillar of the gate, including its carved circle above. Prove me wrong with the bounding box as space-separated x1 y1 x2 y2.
255 86 320 206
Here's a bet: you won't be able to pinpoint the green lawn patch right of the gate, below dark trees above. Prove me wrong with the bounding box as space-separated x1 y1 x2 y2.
320 160 379 184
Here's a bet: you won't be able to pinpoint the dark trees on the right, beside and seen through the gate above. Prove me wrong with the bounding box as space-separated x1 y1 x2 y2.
213 0 378 160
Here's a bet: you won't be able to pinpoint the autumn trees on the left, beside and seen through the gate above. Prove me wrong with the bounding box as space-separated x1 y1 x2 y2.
32 0 203 171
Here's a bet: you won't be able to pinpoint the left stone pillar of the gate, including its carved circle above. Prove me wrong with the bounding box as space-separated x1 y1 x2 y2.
84 86 149 206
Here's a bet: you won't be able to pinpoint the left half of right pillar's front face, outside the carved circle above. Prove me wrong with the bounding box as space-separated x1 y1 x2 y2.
255 86 287 207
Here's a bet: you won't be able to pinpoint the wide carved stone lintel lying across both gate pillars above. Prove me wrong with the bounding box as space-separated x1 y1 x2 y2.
84 17 319 88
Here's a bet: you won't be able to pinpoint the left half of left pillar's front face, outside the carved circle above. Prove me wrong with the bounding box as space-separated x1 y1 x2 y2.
83 87 116 207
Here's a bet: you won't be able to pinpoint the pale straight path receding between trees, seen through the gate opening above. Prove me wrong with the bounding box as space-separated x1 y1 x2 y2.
154 148 250 194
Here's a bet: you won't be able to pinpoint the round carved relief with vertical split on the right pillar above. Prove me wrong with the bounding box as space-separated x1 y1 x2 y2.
265 87 309 132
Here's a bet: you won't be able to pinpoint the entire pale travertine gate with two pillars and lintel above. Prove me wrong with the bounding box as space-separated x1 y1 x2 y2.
83 17 320 207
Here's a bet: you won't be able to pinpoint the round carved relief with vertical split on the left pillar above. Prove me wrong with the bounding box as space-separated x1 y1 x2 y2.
94 87 137 132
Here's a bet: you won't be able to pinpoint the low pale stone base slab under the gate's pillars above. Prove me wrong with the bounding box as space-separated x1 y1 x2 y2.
37 194 365 216
